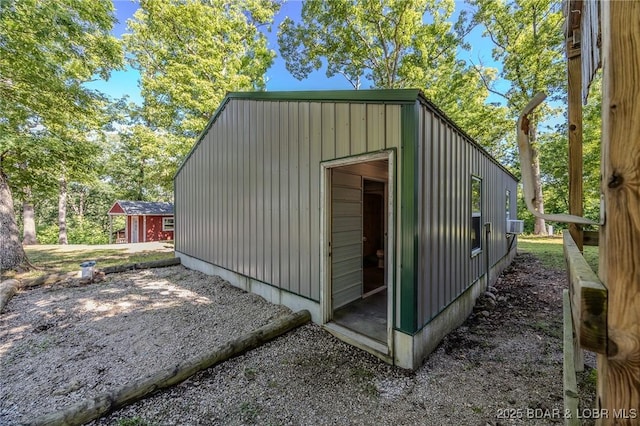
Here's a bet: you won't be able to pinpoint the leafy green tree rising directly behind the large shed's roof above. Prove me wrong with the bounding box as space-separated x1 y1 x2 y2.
278 0 508 149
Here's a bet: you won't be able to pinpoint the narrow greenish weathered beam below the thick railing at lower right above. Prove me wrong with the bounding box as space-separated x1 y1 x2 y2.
562 289 580 426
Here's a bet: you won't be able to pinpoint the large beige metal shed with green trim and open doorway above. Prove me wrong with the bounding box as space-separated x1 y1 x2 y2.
174 90 517 368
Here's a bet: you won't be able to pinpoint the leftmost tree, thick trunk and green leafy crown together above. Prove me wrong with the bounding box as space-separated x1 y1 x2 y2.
0 0 123 270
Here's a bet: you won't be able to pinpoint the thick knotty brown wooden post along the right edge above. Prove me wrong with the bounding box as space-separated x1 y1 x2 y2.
598 1 640 425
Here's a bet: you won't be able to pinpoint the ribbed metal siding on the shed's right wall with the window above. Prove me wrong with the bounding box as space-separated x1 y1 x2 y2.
417 101 516 325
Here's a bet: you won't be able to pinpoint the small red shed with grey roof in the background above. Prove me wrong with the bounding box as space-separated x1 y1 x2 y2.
108 201 173 243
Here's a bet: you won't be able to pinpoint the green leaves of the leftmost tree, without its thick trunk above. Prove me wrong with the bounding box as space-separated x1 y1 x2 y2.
0 0 124 256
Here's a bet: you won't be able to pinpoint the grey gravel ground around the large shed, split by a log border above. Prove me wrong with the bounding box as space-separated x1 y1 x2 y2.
0 253 595 426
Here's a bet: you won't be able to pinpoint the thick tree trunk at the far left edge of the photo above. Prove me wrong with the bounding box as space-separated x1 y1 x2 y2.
0 170 28 273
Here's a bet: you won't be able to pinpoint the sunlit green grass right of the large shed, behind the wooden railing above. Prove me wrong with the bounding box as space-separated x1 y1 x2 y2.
518 235 598 273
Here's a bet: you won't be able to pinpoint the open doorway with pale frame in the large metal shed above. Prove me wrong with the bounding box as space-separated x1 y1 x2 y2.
328 159 389 346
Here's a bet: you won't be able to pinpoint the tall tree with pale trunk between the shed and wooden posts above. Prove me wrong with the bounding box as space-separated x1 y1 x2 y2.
467 0 565 235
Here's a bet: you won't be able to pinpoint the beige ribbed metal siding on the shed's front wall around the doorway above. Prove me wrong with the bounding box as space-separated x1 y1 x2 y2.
175 99 400 300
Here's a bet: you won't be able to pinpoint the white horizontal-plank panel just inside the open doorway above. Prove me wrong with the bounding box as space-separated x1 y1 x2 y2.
331 169 362 310
